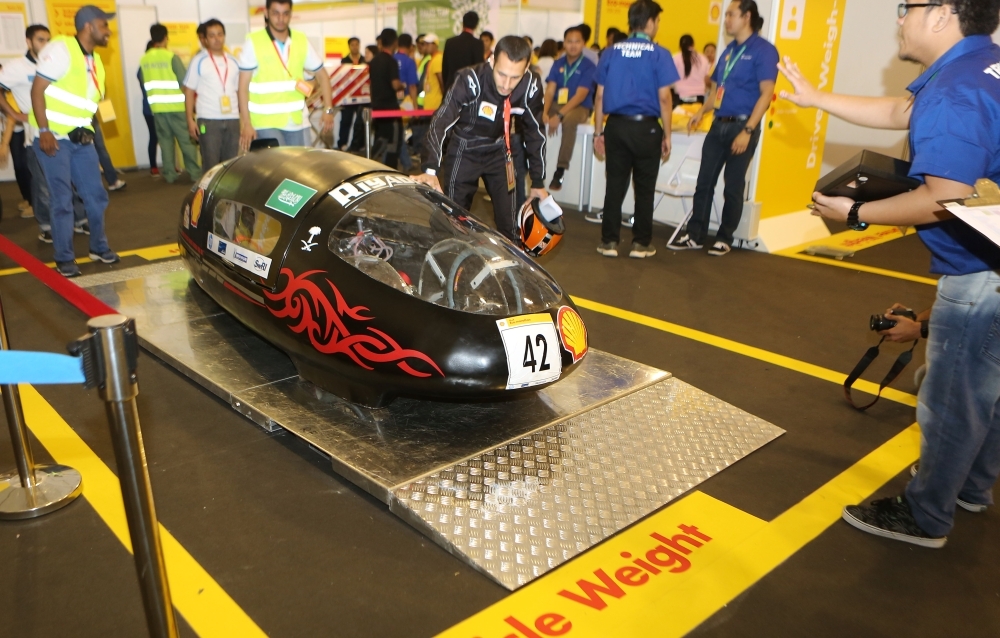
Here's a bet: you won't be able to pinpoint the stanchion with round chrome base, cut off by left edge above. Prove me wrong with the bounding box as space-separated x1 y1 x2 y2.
0 292 83 519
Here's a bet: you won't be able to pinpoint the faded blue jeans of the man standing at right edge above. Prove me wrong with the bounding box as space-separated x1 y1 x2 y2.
906 271 1000 536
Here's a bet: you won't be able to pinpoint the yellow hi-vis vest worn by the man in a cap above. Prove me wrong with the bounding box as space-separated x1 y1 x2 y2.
28 35 104 137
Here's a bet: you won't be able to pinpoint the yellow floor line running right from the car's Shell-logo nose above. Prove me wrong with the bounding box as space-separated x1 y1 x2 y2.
573 297 917 407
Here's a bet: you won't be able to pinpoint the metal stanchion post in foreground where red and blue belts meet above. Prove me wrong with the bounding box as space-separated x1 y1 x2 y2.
70 315 177 638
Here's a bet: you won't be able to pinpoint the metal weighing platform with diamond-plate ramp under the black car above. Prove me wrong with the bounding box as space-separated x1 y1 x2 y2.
75 260 784 589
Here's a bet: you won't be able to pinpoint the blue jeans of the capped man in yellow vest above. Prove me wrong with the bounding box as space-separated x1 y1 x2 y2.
32 139 111 262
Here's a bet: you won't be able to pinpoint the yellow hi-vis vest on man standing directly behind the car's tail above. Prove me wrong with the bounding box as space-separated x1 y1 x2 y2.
247 29 309 129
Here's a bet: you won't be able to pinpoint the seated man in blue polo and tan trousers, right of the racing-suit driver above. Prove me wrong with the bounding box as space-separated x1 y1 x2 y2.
545 27 597 191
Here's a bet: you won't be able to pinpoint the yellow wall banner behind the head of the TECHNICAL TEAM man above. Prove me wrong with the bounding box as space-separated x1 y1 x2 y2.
583 0 722 58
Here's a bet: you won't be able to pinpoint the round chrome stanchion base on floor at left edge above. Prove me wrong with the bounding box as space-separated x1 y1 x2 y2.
0 465 83 520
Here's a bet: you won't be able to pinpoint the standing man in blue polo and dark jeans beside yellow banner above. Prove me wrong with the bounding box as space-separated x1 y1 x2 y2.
667 0 778 257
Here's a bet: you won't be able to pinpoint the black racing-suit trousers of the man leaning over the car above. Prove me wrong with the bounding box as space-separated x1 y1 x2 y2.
438 135 520 244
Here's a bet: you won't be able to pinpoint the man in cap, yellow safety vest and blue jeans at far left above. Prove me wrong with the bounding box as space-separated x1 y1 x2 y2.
29 5 118 277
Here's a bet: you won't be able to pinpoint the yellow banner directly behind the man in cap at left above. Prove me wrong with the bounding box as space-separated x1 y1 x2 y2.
45 0 135 166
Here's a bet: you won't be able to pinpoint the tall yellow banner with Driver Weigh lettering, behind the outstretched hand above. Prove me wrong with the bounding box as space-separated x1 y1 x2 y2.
756 0 845 218
